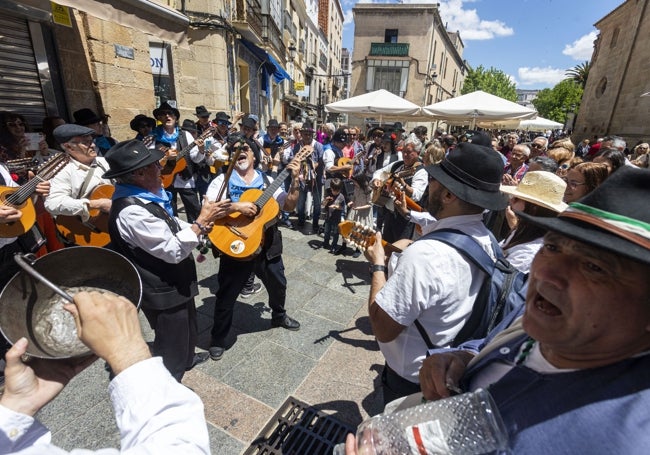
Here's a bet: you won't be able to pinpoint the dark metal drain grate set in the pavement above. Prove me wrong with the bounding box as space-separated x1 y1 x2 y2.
244 397 355 455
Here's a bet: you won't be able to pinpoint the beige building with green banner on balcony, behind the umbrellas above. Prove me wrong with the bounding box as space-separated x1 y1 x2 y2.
350 3 465 130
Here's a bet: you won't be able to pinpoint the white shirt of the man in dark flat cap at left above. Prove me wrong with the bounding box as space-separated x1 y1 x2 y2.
45 156 111 221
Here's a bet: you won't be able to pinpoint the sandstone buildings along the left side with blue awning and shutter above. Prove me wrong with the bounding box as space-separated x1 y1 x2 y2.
0 0 342 140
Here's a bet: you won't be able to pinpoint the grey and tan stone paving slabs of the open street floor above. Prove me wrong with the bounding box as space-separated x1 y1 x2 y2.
38 223 383 455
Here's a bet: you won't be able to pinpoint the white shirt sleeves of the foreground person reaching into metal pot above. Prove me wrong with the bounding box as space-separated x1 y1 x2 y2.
0 357 210 455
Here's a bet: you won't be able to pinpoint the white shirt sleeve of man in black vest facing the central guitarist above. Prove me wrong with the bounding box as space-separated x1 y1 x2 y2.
116 199 199 264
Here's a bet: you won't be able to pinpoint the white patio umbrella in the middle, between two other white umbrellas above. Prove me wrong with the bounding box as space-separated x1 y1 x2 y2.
422 90 537 129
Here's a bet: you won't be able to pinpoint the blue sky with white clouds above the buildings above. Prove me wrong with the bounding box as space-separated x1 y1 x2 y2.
340 0 624 89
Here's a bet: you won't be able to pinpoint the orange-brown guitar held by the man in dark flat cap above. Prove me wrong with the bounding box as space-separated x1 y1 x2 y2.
54 185 115 247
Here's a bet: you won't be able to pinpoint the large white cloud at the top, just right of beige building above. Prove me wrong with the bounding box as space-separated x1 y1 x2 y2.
432 0 515 41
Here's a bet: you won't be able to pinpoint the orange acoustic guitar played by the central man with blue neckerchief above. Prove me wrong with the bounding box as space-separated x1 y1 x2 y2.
208 146 313 260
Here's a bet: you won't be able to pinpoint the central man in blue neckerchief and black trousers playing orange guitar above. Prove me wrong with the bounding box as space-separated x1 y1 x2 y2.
207 135 300 360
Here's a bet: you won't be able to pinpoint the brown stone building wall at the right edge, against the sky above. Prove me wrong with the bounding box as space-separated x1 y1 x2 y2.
572 0 650 146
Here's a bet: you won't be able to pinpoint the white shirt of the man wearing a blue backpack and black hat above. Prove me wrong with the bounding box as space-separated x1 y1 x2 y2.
375 214 496 383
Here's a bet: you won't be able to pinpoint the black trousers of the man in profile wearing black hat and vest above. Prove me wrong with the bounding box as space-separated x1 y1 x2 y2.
142 299 197 382
